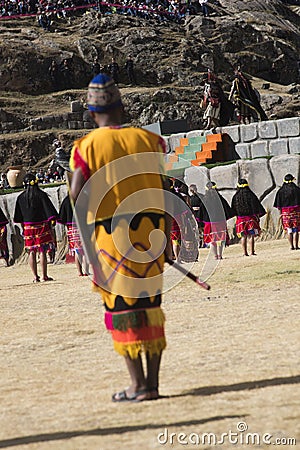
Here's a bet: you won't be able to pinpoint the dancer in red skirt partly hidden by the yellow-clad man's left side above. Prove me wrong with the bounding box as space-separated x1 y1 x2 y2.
58 195 89 277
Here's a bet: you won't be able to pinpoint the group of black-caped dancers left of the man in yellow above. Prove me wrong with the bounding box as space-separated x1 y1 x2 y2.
0 173 89 283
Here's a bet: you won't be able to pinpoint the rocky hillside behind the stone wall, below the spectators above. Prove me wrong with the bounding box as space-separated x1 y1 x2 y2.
0 0 300 169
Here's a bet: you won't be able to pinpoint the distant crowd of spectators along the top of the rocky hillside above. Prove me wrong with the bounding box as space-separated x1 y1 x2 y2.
0 0 201 24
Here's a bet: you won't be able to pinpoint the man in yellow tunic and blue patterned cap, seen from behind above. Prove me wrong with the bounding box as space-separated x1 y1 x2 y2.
70 74 171 402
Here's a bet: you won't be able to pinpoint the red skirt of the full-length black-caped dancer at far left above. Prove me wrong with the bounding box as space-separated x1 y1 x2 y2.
23 222 55 253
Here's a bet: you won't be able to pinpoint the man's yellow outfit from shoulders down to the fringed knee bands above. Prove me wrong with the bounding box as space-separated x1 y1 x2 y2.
70 127 165 357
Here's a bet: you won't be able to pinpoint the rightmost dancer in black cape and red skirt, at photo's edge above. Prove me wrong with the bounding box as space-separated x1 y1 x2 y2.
274 173 300 250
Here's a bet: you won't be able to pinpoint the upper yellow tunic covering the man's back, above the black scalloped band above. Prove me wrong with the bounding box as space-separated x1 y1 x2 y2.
70 127 164 224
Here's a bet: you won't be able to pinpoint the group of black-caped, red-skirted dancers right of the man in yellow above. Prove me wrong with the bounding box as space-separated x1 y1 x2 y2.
171 174 300 263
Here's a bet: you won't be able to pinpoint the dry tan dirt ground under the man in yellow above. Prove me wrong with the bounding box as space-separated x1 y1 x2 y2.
0 239 300 450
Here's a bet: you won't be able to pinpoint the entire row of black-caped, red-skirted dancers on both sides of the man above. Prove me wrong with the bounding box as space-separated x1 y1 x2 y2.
0 173 300 283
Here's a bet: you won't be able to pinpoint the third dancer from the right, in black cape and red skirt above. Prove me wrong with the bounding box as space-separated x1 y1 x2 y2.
199 181 234 259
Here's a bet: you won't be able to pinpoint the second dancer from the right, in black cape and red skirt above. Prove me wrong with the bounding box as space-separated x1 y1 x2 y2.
231 178 266 256
